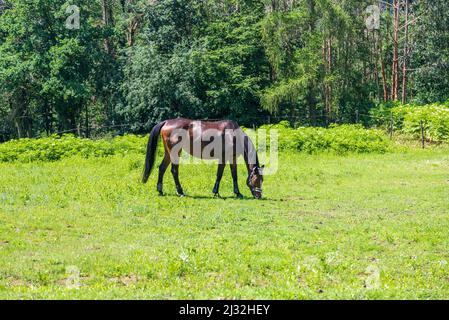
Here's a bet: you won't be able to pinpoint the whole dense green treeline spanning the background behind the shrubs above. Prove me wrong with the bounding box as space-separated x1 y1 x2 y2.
0 0 449 141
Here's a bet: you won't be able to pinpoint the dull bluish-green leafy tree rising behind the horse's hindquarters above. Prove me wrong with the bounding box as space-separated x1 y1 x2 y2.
117 0 202 131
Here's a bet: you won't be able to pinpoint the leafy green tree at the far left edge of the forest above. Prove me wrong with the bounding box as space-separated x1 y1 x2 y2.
0 1 53 138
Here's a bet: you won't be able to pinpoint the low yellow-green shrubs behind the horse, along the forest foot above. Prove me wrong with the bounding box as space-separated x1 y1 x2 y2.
0 122 390 162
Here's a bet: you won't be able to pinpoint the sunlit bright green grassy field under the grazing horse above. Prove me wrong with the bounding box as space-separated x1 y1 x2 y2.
0 149 449 299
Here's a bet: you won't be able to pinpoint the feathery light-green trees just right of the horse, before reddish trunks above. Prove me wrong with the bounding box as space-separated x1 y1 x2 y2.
261 1 375 125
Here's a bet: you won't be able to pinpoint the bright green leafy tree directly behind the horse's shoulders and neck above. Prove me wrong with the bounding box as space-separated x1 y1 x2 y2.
193 7 269 124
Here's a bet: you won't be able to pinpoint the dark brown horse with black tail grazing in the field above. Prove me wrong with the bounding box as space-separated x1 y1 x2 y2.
142 119 263 199
